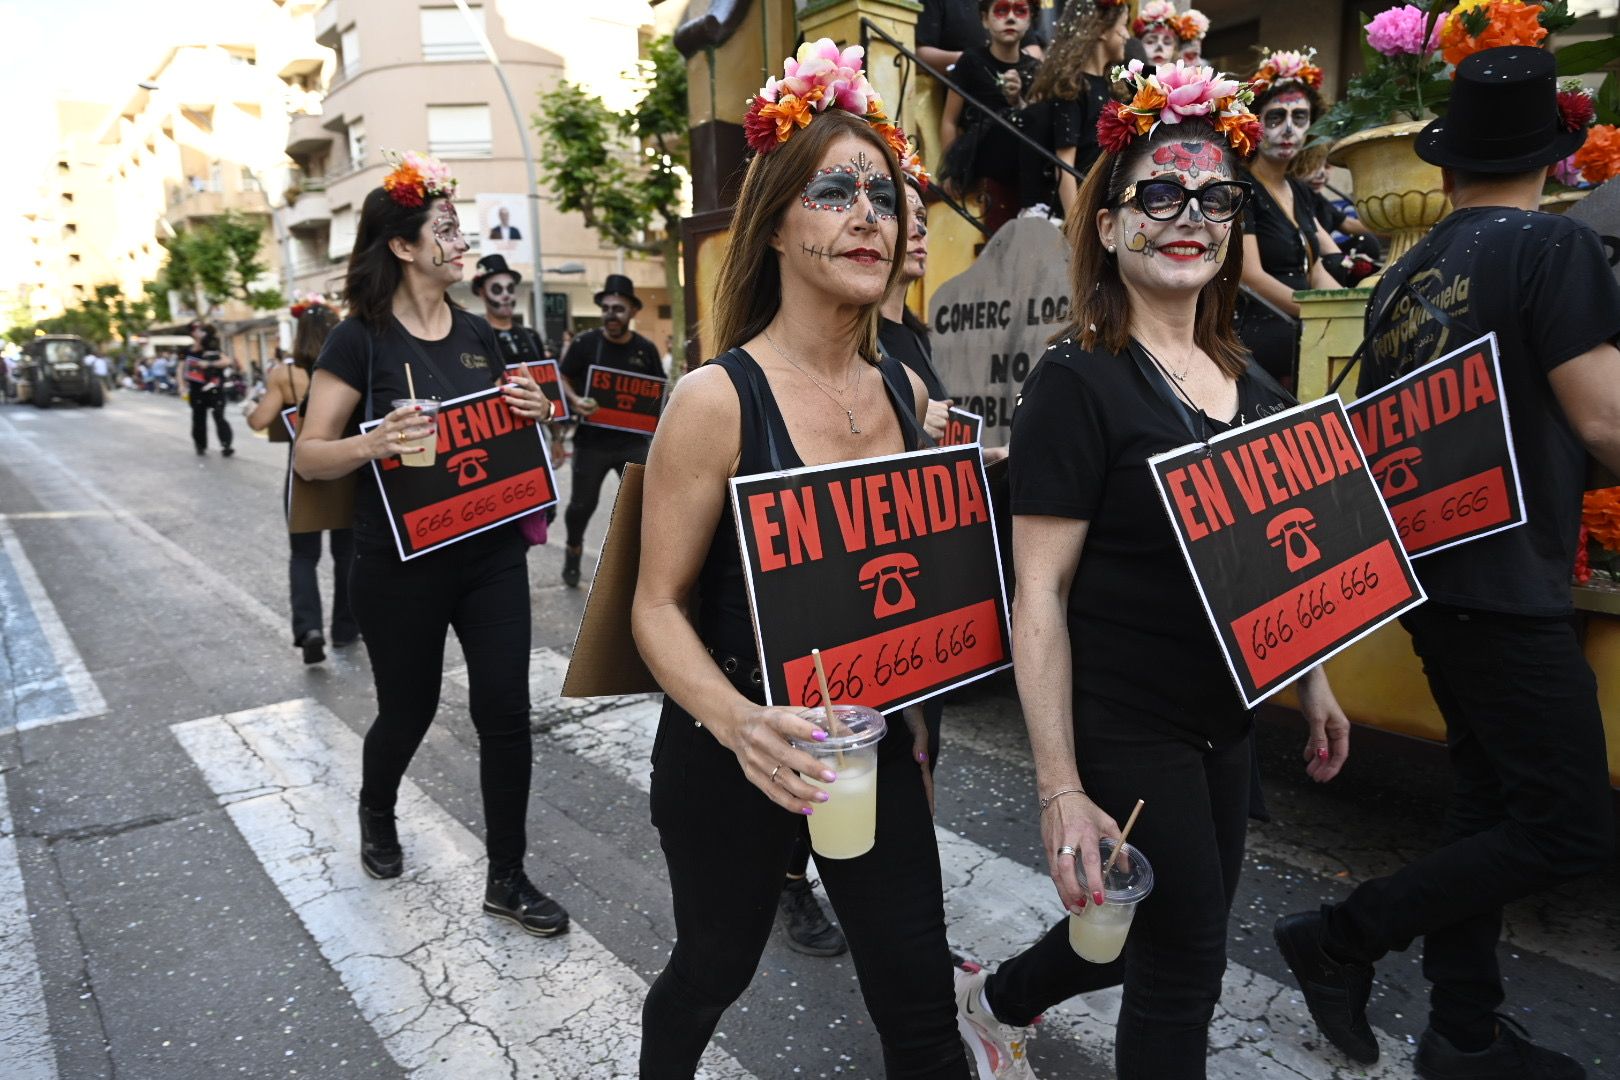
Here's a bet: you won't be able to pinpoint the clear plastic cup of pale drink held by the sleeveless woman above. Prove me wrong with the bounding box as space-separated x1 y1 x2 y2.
794 704 889 858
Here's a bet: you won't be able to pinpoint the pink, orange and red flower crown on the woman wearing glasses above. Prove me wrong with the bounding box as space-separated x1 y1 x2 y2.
1097 60 1260 157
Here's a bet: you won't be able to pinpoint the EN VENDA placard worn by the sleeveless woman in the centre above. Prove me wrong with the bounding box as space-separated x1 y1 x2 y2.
731 447 1013 712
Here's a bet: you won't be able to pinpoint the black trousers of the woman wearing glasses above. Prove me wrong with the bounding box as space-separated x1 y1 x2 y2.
985 699 1251 1080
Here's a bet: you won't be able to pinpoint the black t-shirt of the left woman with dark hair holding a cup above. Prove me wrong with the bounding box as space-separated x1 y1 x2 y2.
314 308 520 557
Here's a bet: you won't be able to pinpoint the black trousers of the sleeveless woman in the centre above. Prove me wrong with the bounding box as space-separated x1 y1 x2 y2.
642 701 970 1080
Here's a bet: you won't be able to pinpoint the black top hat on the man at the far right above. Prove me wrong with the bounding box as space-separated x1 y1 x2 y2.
1418 45 1586 173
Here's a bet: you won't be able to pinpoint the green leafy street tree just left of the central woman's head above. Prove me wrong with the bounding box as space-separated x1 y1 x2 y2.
533 37 689 376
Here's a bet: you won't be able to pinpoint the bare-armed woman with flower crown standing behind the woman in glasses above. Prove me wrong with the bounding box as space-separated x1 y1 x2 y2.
1238 49 1340 387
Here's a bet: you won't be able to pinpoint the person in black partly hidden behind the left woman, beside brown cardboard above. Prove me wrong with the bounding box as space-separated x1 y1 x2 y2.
248 303 360 664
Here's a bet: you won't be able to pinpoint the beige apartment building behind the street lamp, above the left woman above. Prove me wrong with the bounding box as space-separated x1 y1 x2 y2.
277 0 669 345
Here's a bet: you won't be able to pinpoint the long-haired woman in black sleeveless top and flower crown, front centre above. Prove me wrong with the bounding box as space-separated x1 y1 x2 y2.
632 39 969 1080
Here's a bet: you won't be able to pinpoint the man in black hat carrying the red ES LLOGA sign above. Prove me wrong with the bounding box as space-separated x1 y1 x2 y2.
562 274 664 588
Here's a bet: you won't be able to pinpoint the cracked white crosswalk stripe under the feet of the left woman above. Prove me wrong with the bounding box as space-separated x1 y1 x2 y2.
172 699 752 1080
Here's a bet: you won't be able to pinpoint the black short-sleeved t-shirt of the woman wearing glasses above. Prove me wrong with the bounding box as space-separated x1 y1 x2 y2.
1008 342 1288 745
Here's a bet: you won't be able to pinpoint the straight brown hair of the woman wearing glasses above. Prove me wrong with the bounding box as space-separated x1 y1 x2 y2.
1058 120 1249 379
